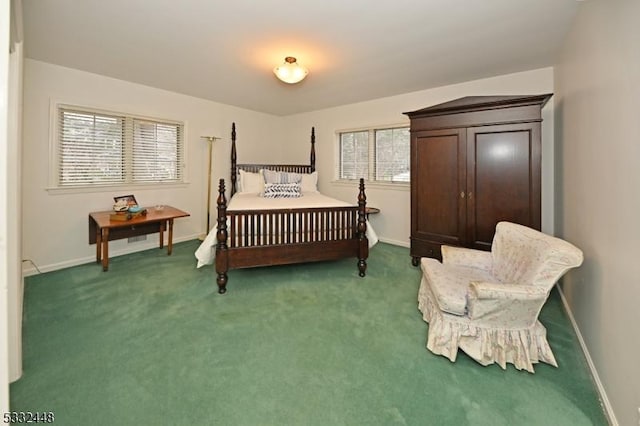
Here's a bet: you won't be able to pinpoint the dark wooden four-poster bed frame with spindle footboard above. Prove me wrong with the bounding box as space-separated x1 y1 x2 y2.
215 123 369 294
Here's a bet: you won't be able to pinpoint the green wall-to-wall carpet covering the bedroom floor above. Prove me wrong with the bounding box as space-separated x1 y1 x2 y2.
10 241 607 426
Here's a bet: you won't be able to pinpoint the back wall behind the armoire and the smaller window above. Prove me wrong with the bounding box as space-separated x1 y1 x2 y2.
284 68 554 246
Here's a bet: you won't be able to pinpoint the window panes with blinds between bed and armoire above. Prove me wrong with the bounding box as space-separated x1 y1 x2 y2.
338 127 410 182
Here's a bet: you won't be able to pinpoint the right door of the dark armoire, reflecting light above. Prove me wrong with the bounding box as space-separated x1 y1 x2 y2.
466 122 541 250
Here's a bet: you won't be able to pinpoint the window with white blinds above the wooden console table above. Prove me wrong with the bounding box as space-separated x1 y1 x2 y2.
55 106 184 188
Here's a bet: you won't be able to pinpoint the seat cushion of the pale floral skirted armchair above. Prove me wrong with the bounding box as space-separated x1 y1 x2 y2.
420 257 496 316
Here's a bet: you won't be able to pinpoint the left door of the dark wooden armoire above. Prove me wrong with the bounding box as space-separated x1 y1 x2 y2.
411 129 467 258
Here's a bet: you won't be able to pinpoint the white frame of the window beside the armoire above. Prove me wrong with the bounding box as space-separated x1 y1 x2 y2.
333 122 411 189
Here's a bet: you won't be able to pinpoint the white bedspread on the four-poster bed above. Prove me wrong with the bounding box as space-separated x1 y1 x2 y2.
195 192 378 268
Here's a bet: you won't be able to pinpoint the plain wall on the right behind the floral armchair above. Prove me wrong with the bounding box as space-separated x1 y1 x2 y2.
555 0 640 425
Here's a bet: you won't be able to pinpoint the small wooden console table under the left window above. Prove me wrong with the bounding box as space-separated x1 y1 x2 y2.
89 206 190 271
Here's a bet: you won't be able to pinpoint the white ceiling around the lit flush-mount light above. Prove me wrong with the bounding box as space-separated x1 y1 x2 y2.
23 0 579 115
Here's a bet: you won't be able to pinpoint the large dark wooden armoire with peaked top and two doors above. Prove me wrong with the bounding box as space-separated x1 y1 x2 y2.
405 94 552 266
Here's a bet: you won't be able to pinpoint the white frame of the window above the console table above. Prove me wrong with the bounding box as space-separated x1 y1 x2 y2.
46 101 189 194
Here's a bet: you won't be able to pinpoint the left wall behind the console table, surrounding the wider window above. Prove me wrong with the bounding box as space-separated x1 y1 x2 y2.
23 59 283 273
